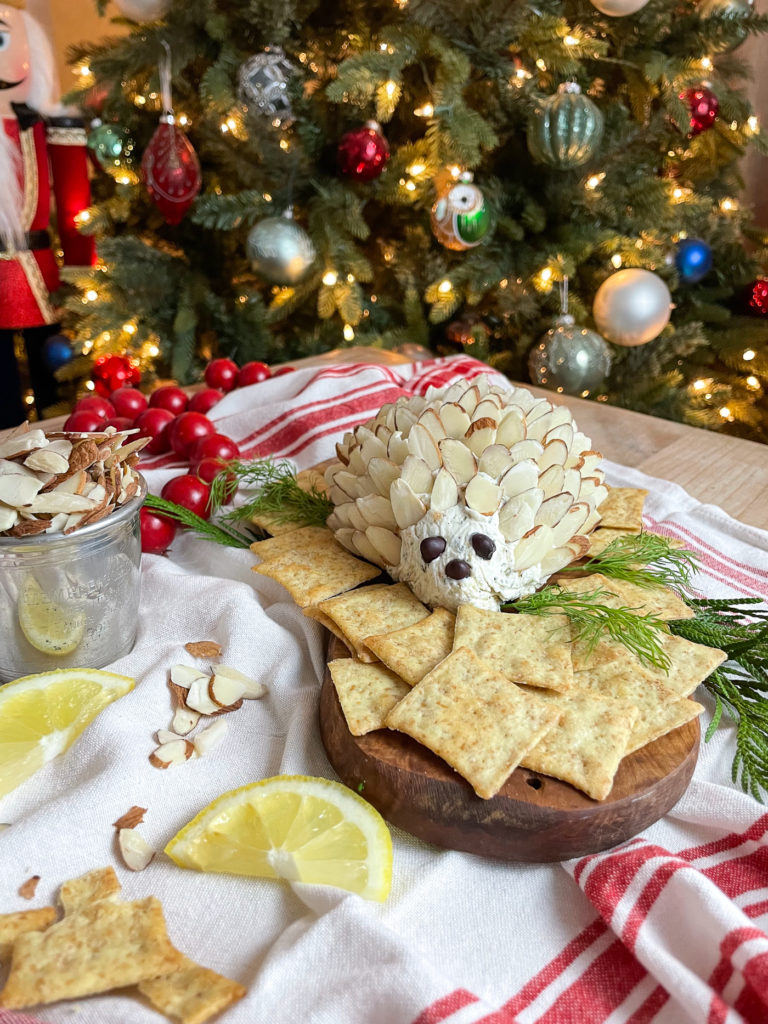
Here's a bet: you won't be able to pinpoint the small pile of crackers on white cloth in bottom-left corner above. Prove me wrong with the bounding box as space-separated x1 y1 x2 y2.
0 867 246 1024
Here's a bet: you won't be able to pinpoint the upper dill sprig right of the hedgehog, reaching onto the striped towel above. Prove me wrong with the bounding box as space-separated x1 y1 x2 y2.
561 534 699 593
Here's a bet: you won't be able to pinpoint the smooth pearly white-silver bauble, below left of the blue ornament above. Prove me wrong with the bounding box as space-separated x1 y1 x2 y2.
592 267 672 347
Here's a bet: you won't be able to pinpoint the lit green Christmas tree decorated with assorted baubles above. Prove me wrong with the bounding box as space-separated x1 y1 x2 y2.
61 0 768 440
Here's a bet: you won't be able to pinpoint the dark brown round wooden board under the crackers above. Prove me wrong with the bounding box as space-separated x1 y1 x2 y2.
319 637 699 862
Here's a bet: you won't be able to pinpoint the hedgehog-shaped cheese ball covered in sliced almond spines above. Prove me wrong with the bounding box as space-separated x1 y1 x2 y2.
326 377 607 611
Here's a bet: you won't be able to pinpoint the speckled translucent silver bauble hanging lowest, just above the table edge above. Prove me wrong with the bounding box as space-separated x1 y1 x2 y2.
528 314 611 398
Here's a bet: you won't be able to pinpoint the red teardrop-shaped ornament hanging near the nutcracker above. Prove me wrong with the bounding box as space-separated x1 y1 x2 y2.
141 114 203 224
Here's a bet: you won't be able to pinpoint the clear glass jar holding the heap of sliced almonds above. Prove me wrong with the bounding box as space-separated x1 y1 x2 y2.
0 475 146 682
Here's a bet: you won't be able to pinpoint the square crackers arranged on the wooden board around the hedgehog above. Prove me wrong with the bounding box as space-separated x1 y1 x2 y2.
252 487 726 801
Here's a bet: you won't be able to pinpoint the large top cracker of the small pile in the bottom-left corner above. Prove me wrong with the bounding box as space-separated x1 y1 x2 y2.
0 896 184 1010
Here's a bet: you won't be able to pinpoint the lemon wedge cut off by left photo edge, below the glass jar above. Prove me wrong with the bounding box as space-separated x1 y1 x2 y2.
0 669 134 797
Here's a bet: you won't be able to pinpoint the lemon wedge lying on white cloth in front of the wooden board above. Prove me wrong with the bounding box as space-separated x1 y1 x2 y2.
165 775 392 901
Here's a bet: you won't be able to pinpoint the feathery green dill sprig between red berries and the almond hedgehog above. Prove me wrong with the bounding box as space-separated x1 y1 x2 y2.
211 459 333 526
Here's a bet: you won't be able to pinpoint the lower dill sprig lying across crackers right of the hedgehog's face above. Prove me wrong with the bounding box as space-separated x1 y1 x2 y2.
504 585 670 670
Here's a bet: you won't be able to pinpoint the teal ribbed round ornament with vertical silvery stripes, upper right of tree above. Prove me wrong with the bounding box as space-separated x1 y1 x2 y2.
527 82 603 170
